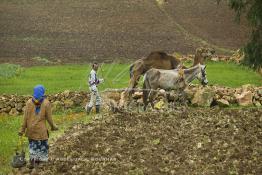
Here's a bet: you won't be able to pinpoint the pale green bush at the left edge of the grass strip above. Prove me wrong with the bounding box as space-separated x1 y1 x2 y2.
0 63 23 78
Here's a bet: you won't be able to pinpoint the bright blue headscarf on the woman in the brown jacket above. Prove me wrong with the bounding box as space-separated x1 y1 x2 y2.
32 85 45 114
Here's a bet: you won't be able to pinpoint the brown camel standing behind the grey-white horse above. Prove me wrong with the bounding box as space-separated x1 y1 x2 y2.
128 48 215 94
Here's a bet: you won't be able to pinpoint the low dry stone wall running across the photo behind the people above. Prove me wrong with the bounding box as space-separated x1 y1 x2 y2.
0 85 262 115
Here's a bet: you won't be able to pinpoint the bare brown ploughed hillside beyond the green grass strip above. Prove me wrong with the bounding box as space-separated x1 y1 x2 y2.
0 0 248 65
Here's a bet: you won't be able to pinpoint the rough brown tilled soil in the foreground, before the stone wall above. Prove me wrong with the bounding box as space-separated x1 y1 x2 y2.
37 108 262 174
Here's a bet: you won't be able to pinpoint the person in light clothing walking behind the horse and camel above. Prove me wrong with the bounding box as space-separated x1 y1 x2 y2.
85 63 104 114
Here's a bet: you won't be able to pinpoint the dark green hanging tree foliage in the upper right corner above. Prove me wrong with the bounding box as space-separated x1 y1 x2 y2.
217 0 262 69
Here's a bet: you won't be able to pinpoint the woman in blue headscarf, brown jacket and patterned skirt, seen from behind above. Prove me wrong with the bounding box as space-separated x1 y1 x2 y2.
19 85 58 169
